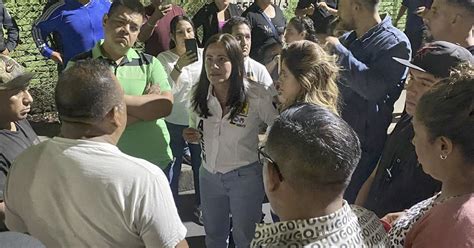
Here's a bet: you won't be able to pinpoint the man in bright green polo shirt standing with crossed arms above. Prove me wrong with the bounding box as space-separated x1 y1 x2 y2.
68 0 173 169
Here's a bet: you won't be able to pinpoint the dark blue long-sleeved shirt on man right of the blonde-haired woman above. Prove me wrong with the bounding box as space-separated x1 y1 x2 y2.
335 16 411 152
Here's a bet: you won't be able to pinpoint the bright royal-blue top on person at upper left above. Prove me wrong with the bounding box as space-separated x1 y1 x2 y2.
31 0 110 65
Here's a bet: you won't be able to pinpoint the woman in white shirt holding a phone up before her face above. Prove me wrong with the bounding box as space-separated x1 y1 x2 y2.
157 16 202 213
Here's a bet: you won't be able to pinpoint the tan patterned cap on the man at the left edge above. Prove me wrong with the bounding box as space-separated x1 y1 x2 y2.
0 55 33 90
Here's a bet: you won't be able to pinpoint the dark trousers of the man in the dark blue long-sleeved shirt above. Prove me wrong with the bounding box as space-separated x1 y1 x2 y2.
344 151 381 204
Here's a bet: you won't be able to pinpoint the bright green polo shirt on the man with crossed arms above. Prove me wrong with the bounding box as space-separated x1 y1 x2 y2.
67 41 173 169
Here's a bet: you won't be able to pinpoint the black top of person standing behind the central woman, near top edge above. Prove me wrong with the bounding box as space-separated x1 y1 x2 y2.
242 3 286 64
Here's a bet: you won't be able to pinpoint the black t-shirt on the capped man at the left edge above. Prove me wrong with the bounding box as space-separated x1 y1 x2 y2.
0 120 39 201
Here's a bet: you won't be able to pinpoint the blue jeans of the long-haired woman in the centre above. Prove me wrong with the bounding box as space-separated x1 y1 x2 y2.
199 162 265 248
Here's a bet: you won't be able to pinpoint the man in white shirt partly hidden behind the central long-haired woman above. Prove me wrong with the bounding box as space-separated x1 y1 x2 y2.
222 16 278 93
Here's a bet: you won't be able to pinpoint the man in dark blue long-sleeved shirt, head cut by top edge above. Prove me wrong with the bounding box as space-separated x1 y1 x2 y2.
326 0 411 203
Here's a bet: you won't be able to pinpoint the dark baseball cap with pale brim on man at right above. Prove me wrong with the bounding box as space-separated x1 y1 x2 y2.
393 41 474 78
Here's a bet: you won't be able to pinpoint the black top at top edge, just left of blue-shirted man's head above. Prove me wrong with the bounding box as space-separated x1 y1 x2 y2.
296 0 338 33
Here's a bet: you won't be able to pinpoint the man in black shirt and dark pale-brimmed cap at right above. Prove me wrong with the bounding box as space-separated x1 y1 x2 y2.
356 41 474 218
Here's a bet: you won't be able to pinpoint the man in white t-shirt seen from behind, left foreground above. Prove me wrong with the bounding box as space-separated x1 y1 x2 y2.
5 59 188 247
